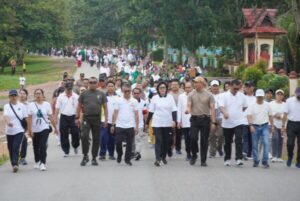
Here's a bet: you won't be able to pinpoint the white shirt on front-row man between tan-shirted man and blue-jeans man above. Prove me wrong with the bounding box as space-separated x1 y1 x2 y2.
219 91 247 128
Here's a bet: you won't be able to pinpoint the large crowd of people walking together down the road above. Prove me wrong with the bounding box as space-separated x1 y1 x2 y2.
3 48 300 172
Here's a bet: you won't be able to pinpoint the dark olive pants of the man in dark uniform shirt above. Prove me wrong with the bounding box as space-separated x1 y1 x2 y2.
81 115 101 158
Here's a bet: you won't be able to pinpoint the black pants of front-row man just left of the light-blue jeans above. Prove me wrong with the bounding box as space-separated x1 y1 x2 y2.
223 125 243 161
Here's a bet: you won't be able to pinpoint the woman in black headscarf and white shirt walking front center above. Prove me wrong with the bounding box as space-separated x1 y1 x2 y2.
147 82 177 167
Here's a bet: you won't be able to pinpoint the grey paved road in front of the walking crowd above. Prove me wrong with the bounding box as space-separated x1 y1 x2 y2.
0 61 300 201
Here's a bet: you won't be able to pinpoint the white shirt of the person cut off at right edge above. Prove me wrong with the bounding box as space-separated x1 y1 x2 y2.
284 96 300 121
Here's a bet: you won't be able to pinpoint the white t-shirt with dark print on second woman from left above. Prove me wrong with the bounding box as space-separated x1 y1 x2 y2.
28 101 52 133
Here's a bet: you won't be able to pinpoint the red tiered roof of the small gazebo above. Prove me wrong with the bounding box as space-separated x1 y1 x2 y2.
239 8 287 35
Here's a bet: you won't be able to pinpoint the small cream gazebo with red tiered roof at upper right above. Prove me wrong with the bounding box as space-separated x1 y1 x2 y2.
239 8 287 70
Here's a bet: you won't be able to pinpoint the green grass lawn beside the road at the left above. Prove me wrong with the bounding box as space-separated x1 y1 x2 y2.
0 56 76 90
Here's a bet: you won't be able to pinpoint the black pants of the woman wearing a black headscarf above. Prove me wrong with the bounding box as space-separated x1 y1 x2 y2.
153 127 172 161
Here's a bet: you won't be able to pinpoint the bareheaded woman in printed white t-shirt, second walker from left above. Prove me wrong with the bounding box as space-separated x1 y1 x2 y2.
28 89 57 171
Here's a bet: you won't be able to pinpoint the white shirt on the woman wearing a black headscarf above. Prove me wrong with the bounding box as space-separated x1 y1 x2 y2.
149 94 177 127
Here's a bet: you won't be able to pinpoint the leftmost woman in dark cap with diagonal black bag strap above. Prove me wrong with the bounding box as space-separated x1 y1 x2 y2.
3 90 28 173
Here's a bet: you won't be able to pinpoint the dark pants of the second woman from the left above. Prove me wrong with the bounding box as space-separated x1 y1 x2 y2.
32 129 49 164
